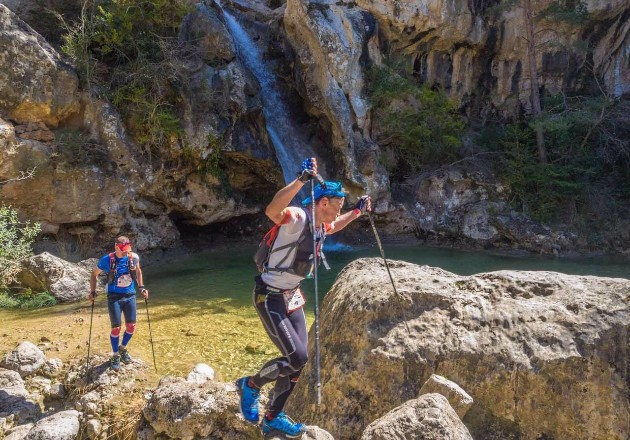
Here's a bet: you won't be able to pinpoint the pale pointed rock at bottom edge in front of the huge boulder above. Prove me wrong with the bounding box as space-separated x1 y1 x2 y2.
361 393 472 440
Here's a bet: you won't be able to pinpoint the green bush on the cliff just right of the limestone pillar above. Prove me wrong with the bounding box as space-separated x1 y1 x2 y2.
368 66 464 174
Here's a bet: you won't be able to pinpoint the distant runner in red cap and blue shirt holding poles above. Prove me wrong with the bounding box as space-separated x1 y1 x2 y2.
88 236 149 371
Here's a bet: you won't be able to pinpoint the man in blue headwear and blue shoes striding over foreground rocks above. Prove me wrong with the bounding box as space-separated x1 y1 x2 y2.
236 158 371 438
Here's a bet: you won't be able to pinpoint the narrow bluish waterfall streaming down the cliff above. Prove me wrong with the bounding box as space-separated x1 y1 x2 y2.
215 0 324 183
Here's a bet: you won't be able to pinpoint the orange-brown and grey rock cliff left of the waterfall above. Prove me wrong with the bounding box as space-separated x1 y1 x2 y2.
0 5 280 250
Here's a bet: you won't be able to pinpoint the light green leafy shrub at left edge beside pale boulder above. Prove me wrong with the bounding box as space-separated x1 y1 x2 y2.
0 205 40 289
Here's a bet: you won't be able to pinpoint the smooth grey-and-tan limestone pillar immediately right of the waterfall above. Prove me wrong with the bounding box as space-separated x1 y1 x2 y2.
284 0 388 197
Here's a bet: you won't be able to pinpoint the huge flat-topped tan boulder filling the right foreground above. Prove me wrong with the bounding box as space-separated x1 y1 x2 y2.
290 259 630 440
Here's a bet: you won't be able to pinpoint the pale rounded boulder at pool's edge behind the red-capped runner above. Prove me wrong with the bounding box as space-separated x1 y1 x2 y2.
16 252 90 302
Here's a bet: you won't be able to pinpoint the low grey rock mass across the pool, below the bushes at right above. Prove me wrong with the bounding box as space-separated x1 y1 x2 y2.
398 166 577 254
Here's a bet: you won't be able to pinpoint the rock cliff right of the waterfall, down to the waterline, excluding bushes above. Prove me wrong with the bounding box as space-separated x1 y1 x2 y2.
284 0 630 253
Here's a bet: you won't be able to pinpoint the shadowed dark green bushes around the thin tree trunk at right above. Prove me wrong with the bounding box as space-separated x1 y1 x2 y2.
478 95 630 226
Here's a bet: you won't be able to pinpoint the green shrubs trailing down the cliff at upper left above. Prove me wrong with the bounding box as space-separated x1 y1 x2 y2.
62 0 191 162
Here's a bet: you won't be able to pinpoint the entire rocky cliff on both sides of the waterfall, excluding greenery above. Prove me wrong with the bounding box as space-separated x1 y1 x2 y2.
0 0 630 253
